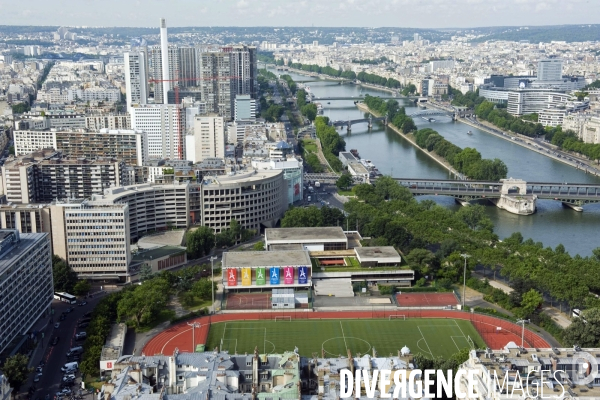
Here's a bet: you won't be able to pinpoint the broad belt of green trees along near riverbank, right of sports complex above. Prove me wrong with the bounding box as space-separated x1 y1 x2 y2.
332 177 600 338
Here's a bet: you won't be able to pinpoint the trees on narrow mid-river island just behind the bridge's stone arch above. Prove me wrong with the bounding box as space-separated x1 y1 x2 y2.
415 128 508 181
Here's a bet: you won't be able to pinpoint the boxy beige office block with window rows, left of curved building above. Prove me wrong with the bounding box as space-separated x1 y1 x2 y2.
50 200 131 280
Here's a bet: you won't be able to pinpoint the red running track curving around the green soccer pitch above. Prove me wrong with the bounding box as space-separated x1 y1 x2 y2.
142 310 551 355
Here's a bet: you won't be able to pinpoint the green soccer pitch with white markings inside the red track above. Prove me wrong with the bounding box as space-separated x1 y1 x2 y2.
207 318 486 357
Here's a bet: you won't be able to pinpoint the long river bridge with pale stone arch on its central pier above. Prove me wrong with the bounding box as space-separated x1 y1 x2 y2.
394 178 600 215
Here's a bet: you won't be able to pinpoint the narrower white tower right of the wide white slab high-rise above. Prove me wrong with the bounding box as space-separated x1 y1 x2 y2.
185 114 225 163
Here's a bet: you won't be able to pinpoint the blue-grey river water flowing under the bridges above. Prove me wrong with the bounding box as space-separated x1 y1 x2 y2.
272 70 600 256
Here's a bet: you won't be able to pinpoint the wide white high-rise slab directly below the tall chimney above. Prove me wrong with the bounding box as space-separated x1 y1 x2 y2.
130 104 185 160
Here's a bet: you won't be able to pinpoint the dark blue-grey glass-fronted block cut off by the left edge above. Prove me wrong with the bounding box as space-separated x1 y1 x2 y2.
0 229 54 353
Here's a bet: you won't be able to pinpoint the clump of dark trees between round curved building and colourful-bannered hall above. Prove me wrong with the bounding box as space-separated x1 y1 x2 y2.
186 218 256 259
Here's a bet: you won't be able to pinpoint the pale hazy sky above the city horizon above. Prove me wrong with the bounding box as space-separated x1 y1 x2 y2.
0 0 600 28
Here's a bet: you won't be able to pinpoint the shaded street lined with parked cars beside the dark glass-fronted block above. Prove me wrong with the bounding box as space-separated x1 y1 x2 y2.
34 293 105 399
